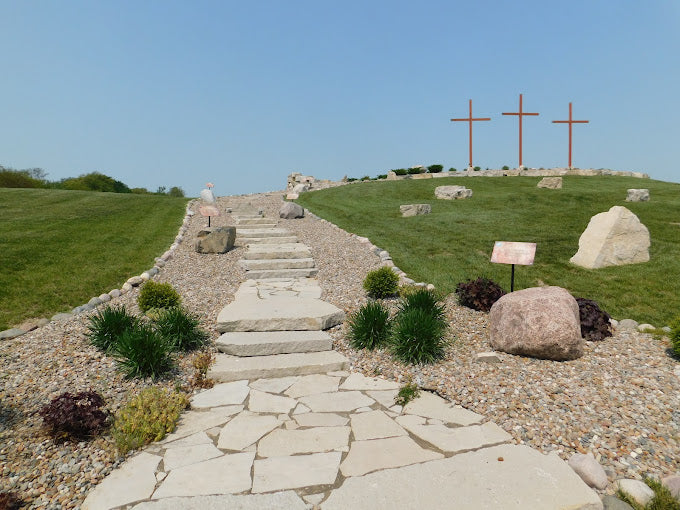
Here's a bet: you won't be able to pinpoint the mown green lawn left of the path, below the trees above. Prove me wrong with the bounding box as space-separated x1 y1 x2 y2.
0 189 187 330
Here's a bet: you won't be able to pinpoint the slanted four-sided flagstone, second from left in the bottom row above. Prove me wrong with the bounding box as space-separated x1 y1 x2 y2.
153 452 255 499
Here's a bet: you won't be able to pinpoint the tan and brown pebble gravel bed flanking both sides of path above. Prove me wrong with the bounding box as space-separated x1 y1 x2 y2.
0 192 680 509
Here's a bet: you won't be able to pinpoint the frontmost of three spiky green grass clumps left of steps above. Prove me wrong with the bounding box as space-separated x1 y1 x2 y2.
112 323 174 379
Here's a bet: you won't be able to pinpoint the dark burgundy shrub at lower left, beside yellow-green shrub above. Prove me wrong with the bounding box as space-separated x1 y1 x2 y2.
38 391 109 440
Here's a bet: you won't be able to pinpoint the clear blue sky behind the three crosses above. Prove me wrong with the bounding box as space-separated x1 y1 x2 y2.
0 0 680 196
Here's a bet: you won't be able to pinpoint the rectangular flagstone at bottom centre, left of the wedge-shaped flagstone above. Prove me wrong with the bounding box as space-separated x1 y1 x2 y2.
252 452 342 493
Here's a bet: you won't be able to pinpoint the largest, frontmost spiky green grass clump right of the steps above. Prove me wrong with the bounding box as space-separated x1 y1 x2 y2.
392 307 446 363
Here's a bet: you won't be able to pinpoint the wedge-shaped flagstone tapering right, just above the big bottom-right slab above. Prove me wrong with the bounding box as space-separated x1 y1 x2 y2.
340 437 444 478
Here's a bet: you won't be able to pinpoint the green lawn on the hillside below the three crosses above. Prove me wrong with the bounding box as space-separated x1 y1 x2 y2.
298 176 680 326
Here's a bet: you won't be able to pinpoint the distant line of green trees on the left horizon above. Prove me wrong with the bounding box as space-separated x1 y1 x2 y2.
0 165 184 197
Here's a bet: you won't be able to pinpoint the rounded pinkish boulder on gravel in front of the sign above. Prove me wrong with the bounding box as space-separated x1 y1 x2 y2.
489 287 584 361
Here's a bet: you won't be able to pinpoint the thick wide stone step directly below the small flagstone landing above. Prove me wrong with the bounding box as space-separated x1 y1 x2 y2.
216 294 345 333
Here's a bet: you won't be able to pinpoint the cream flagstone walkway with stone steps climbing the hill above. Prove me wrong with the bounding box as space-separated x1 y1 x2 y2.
83 207 602 510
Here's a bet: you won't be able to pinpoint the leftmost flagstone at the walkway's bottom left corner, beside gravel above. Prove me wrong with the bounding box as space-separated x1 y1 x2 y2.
83 452 162 510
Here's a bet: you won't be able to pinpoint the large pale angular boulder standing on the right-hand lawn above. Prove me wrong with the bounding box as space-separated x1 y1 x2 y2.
570 205 650 269
